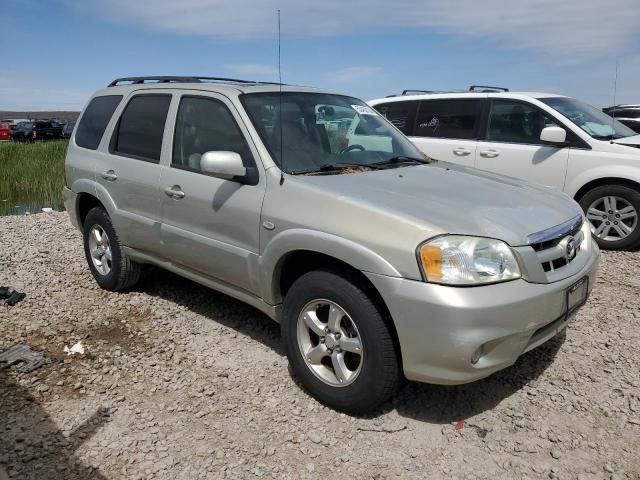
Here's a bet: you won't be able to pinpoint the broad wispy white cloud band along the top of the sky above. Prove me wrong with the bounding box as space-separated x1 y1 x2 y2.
84 0 640 62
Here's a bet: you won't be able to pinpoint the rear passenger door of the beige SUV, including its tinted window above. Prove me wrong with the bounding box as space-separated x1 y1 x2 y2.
96 90 172 253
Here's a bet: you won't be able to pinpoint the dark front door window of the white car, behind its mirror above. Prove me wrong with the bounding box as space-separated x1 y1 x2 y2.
486 100 558 145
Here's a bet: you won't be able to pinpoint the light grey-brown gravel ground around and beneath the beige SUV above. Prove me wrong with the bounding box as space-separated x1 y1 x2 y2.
0 213 640 480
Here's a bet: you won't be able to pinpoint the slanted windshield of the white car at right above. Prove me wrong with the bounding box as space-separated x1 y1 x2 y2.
538 97 636 140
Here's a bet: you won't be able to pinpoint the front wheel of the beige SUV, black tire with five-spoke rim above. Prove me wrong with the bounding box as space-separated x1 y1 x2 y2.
282 270 403 414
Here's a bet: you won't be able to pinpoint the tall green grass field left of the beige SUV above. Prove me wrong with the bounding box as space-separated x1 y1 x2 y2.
0 140 69 215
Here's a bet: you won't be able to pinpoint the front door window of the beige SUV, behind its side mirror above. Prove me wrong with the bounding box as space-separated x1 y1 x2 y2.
171 97 254 172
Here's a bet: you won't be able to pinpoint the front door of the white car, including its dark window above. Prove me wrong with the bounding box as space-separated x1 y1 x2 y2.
476 98 570 189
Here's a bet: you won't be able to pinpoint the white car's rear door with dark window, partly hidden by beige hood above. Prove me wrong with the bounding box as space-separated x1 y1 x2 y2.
410 97 484 167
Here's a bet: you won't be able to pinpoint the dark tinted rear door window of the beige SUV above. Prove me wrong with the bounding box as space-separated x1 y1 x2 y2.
111 94 171 163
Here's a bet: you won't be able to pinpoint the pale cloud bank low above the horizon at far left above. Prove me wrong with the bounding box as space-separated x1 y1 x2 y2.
0 72 91 111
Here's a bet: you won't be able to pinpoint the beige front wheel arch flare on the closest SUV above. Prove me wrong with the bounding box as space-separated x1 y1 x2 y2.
258 228 401 305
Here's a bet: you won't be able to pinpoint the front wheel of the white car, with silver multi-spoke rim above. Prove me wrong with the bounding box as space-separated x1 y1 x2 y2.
580 185 640 250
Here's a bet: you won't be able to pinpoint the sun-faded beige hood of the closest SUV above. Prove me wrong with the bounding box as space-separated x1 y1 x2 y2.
297 162 582 246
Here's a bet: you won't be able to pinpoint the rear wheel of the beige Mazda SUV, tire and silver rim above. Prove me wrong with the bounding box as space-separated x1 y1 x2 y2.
82 207 141 292
